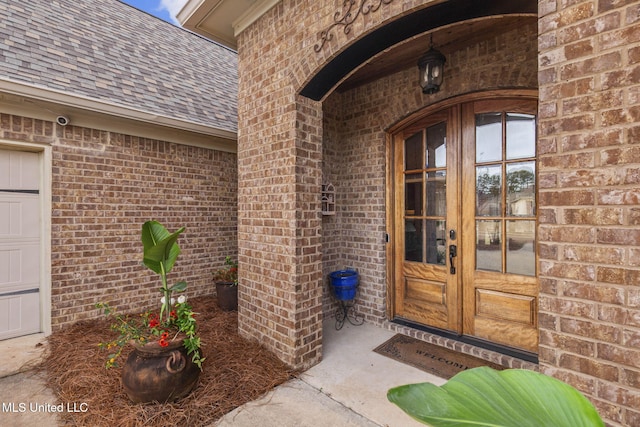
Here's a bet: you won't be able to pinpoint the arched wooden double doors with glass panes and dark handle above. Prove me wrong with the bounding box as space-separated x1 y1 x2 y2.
393 99 538 353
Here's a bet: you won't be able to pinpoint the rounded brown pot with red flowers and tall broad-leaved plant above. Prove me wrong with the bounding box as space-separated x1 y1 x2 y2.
96 221 205 402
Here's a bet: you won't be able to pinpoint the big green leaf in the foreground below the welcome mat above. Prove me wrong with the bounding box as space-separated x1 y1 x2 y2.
387 367 604 427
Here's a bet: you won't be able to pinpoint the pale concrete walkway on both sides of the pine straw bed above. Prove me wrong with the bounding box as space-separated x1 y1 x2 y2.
0 320 445 427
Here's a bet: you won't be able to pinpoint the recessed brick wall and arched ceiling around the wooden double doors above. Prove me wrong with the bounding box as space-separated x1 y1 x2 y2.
316 2 537 359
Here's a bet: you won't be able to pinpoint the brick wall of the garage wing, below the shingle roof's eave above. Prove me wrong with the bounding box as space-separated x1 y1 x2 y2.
0 115 237 330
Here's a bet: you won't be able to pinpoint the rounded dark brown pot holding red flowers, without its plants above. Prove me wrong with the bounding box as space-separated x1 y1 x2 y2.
122 339 200 403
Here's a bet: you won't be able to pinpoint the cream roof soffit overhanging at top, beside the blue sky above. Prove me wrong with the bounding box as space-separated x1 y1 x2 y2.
177 0 280 50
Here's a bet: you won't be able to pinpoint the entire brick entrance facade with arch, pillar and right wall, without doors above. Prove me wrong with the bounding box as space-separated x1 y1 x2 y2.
183 0 640 426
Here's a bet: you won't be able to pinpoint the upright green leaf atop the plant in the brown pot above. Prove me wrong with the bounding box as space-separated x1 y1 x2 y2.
142 221 184 274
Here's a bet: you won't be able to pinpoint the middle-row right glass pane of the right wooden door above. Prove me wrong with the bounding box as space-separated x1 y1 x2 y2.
507 162 536 216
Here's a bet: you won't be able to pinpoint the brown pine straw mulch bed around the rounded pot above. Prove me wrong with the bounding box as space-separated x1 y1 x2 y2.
41 297 296 427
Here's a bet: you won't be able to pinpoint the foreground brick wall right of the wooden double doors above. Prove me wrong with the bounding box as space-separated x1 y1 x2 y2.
539 0 640 426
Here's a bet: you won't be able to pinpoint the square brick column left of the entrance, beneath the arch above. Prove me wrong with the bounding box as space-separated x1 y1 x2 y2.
238 89 322 369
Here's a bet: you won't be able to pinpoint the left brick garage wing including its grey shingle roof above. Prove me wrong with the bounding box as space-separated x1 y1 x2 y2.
0 0 237 339
